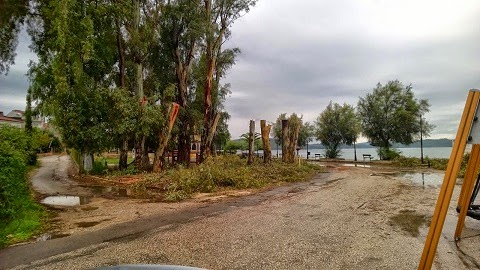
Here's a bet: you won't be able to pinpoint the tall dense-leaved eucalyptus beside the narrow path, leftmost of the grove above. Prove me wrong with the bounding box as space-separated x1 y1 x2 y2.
29 1 122 171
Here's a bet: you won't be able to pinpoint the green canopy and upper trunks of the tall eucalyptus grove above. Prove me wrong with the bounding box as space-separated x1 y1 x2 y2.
0 0 256 172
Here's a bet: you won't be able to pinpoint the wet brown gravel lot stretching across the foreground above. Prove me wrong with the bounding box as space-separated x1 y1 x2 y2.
6 167 480 269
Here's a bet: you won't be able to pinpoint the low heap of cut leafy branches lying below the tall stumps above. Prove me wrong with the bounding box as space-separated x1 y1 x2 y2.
136 156 322 201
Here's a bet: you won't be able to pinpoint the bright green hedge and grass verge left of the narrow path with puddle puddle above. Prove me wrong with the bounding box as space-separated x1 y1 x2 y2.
0 125 53 247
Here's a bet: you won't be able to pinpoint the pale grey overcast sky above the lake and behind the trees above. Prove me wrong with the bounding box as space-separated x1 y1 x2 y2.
0 0 480 141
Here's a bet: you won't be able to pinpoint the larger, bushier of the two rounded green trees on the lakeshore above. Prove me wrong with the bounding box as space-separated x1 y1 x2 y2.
357 80 433 158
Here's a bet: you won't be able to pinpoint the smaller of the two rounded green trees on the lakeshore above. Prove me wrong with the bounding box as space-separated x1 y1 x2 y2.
315 101 360 158
